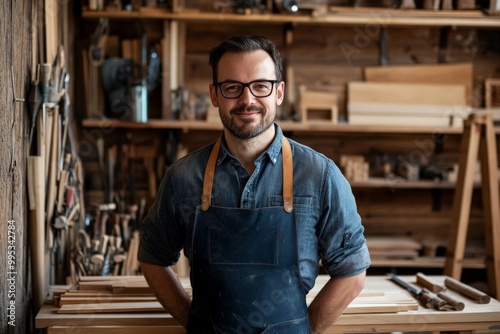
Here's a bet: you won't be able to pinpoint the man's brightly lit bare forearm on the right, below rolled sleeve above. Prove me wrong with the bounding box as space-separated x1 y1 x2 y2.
309 272 365 334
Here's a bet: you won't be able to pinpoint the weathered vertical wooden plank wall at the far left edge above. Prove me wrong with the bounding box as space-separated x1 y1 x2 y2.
0 0 35 333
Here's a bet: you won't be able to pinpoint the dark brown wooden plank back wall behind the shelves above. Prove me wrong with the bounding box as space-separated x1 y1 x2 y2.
185 22 500 255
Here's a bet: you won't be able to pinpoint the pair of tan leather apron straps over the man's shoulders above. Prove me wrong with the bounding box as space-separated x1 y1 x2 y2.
201 136 293 213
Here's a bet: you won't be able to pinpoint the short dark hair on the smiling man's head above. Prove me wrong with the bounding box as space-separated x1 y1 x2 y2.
208 35 283 83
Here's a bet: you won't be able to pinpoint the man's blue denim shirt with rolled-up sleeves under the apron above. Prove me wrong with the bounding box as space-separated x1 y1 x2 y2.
138 124 370 291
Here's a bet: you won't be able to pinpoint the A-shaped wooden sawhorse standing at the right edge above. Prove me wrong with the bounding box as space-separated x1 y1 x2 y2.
444 113 500 299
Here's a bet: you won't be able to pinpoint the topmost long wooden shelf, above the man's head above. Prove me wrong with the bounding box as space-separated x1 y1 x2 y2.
83 7 500 28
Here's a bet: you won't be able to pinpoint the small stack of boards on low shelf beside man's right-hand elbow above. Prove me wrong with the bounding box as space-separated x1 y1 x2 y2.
366 236 422 259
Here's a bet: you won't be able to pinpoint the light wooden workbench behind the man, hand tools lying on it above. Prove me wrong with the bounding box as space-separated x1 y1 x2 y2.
35 276 500 334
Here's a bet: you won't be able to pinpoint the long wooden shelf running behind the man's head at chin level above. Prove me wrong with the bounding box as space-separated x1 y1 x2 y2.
82 118 462 134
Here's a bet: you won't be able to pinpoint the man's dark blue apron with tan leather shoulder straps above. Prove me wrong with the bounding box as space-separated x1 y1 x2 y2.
187 137 310 334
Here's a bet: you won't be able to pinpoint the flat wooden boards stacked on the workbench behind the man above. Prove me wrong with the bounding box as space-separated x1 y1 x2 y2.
54 276 418 314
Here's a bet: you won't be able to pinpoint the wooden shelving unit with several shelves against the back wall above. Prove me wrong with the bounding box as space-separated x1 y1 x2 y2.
82 7 500 269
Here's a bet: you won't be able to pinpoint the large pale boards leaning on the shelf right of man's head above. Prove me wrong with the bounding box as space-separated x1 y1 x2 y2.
347 64 472 127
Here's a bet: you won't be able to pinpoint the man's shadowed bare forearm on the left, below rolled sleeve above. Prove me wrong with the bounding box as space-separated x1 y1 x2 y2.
141 263 191 328
